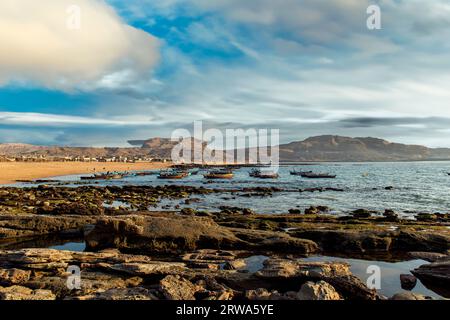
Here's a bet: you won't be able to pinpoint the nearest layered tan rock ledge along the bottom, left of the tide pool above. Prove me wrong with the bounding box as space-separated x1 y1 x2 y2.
0 249 378 300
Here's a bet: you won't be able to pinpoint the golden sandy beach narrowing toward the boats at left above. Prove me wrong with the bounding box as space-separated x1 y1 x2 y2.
0 162 170 184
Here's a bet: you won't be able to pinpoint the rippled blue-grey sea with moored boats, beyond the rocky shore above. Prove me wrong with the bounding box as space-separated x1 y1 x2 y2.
22 161 450 216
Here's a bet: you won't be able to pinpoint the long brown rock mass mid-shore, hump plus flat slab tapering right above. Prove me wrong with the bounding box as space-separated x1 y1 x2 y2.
86 214 318 254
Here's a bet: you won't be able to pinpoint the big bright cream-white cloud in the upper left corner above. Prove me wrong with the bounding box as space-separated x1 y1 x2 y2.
0 0 158 90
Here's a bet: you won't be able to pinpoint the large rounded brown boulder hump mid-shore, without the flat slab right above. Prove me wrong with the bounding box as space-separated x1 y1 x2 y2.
86 215 242 254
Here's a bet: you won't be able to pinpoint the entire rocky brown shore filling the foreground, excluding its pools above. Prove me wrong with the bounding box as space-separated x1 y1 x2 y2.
0 186 450 300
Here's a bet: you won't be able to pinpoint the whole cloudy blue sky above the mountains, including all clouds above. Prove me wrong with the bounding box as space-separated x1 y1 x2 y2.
0 0 450 147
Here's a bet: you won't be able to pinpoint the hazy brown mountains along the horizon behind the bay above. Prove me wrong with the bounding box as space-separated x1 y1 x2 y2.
0 135 450 162
